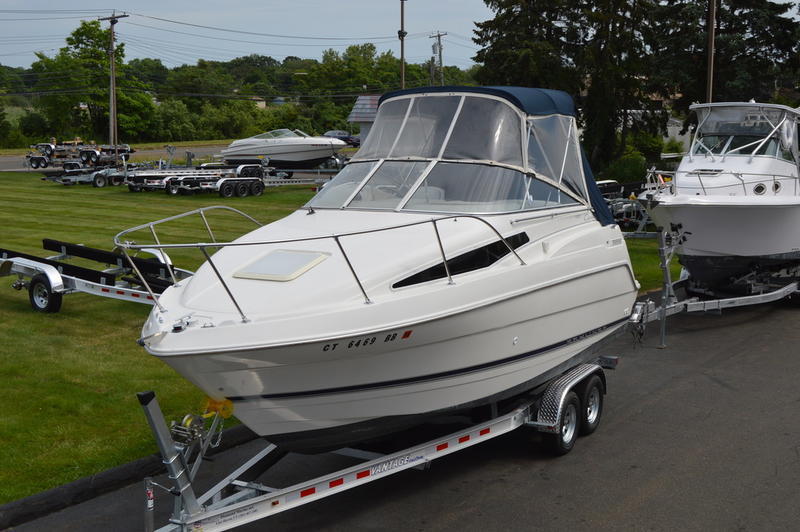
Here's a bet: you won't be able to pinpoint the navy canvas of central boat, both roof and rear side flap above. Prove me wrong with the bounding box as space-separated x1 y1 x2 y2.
379 85 614 225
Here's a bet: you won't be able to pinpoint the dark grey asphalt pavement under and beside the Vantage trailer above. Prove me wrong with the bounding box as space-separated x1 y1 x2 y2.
6 302 800 532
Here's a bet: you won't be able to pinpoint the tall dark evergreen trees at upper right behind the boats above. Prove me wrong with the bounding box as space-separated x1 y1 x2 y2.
474 0 800 176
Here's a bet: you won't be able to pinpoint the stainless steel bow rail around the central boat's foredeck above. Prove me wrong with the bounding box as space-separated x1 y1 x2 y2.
114 205 525 322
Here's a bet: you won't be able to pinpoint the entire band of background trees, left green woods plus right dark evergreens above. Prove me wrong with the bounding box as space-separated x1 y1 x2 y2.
0 0 800 181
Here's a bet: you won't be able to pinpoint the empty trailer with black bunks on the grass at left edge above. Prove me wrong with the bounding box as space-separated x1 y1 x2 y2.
0 238 192 312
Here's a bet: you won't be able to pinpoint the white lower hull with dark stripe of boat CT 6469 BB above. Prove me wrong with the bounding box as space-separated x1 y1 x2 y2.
162 266 635 451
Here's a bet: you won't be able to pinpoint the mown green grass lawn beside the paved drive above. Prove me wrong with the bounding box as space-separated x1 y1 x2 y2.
0 172 661 504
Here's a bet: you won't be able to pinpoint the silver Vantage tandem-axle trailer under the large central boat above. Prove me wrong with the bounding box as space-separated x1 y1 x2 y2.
138 358 617 532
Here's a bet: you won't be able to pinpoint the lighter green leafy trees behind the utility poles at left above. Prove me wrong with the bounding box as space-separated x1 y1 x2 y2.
0 21 475 147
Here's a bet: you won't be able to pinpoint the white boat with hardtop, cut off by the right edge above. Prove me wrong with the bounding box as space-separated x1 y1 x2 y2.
643 102 800 291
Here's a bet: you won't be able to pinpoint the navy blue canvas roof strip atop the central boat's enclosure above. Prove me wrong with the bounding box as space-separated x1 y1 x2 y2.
380 86 575 116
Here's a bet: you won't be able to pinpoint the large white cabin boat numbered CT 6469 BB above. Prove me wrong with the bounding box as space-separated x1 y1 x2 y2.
122 87 638 450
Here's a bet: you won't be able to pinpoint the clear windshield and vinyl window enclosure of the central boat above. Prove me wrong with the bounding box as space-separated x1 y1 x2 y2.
307 93 588 214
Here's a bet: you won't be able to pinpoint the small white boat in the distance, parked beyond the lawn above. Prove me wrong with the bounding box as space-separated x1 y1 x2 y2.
222 129 347 169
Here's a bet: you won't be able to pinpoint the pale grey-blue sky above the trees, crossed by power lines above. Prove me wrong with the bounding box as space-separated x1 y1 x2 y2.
0 0 492 68
